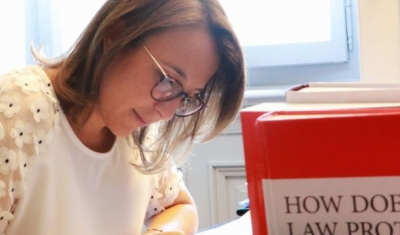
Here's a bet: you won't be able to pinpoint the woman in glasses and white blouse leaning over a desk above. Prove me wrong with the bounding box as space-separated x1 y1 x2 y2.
0 0 245 235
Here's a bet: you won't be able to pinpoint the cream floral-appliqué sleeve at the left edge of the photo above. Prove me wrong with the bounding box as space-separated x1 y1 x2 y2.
0 66 59 234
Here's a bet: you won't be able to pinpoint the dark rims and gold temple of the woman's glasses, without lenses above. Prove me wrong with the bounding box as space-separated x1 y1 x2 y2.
141 42 207 117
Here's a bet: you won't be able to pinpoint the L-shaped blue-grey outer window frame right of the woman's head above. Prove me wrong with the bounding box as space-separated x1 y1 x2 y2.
242 0 361 90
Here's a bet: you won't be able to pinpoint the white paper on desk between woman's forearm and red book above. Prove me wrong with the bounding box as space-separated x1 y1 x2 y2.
197 211 253 235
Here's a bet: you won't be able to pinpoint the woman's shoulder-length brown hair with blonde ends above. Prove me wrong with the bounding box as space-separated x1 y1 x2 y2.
34 0 245 173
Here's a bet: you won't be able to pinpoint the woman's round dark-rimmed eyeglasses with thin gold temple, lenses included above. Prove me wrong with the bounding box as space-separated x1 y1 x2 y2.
142 43 207 117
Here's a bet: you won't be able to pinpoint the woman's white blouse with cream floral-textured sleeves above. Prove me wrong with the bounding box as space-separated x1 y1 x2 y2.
0 66 184 235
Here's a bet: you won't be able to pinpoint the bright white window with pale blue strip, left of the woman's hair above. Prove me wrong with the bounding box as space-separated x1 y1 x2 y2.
0 0 105 74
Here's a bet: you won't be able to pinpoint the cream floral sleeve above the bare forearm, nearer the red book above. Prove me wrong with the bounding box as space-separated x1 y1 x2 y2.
146 166 185 221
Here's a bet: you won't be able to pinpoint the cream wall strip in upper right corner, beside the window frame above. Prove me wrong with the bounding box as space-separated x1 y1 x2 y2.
358 0 400 82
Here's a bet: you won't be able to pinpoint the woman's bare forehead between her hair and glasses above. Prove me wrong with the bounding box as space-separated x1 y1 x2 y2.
144 26 219 90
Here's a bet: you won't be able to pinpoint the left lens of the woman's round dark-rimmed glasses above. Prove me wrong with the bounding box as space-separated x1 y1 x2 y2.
151 77 182 101
